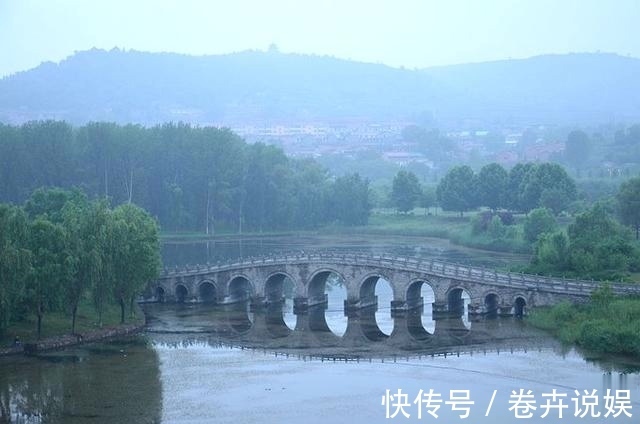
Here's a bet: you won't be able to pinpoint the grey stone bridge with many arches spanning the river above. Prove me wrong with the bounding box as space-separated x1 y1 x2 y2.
144 253 640 317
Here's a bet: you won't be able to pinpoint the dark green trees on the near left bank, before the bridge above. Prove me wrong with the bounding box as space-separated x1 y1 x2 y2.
0 189 160 337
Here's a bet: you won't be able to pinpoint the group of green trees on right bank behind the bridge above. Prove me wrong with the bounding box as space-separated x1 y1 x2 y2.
390 163 640 279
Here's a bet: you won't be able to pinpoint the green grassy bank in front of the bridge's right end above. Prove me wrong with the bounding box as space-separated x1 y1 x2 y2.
528 296 640 357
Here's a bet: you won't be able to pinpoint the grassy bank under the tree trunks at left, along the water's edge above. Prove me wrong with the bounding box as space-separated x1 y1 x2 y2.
0 301 144 347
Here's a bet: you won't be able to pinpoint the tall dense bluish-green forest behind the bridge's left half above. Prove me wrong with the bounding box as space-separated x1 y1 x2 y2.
0 121 371 234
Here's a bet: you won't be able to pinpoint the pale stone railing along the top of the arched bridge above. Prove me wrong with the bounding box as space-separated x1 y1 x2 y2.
161 251 640 295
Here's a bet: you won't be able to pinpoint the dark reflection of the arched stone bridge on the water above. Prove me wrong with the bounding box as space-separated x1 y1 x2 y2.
144 302 559 360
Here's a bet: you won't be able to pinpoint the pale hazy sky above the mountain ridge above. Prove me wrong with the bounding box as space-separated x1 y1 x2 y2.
0 0 640 76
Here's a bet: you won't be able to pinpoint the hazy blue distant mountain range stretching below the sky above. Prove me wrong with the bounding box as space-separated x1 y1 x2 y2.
0 49 640 126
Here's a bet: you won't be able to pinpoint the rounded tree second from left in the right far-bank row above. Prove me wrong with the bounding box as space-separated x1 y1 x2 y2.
436 165 476 216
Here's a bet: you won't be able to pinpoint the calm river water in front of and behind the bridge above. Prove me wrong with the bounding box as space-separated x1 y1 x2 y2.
0 236 640 424
